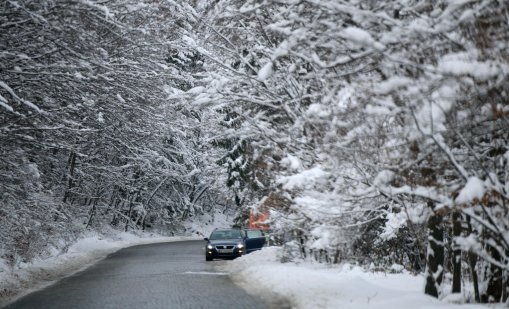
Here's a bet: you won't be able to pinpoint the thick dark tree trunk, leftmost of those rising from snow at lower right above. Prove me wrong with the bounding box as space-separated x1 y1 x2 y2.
424 212 444 298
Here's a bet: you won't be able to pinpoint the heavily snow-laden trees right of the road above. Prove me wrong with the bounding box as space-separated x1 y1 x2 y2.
191 1 509 301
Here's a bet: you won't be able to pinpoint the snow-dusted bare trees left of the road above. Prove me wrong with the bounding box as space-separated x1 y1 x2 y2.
0 0 226 263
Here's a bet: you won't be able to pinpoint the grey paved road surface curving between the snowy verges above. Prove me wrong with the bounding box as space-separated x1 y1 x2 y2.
6 241 272 309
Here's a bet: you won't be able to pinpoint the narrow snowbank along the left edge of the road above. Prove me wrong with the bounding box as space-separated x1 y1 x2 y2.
0 232 201 307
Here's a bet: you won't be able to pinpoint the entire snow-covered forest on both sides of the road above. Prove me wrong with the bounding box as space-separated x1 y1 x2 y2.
0 0 509 302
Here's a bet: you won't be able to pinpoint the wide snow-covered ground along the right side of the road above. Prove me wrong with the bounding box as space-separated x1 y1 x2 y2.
228 247 503 309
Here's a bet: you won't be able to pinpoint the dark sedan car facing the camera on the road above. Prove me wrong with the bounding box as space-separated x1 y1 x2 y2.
205 229 265 261
